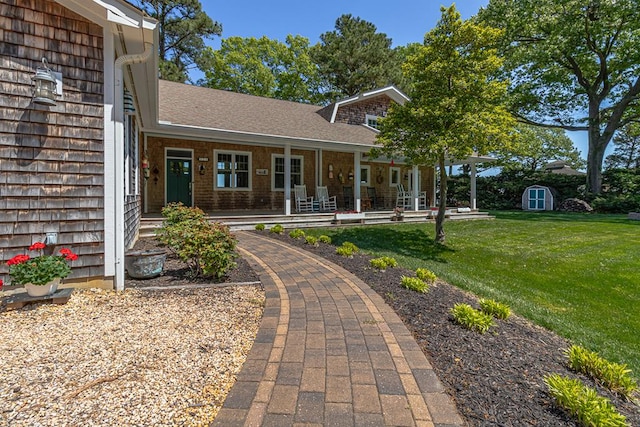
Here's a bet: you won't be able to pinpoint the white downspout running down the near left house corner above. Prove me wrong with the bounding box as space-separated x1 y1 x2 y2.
113 43 153 291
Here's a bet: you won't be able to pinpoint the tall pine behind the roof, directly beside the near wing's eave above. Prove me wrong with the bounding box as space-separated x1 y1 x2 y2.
134 0 222 82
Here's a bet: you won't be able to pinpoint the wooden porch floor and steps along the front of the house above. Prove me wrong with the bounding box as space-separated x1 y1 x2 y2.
139 208 493 237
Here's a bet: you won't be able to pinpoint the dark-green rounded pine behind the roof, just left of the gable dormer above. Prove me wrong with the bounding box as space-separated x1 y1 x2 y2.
311 14 397 97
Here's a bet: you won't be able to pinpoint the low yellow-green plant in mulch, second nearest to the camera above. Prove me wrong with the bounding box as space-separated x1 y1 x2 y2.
567 345 638 397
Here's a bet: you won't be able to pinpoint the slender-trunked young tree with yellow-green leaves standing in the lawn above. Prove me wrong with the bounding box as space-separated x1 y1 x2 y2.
378 6 514 243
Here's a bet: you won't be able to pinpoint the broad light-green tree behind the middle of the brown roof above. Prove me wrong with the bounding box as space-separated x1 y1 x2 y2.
199 35 323 103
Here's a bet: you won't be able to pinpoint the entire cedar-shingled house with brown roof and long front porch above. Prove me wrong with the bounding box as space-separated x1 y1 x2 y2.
0 0 486 289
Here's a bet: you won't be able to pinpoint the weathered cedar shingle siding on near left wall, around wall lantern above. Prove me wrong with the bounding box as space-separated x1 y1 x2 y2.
0 0 104 279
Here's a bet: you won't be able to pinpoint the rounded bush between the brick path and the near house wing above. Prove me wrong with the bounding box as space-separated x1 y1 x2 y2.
157 204 237 278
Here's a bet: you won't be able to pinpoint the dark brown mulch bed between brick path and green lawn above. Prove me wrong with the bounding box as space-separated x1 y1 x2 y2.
263 232 640 426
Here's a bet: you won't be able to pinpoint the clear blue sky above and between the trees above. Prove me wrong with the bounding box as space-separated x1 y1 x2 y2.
200 0 596 162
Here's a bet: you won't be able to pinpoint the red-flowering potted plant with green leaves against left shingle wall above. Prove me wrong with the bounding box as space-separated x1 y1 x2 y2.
7 242 78 286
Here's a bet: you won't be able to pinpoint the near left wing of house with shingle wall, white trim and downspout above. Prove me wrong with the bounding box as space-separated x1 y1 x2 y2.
0 0 158 288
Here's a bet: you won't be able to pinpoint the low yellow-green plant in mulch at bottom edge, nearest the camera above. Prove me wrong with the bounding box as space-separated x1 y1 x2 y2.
544 374 628 427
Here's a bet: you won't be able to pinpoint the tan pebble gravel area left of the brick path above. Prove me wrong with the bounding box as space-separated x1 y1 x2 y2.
0 263 264 426
